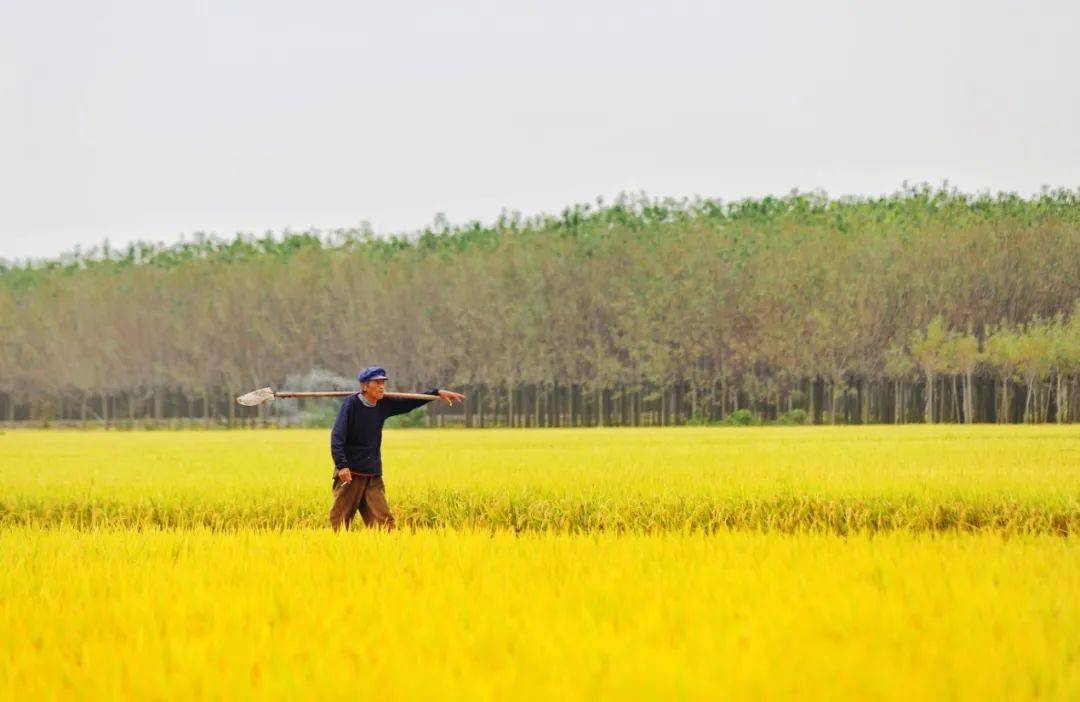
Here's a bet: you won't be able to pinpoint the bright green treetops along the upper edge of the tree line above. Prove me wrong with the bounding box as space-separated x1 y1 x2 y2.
0 184 1080 282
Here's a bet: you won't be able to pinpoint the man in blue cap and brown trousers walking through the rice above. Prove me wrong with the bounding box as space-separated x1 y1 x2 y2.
330 366 464 531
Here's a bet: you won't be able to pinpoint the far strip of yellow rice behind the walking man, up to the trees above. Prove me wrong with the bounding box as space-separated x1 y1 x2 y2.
0 426 1080 535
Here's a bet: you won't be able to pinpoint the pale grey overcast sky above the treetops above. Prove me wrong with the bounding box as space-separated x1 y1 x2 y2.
0 0 1080 259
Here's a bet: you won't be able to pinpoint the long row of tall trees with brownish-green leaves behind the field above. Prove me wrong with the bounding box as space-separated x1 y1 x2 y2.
0 187 1080 427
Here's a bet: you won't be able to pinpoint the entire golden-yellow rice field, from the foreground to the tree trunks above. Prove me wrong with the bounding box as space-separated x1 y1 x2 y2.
0 426 1080 700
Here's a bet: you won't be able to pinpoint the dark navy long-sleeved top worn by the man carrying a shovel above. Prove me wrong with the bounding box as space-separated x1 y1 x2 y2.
330 390 438 475
